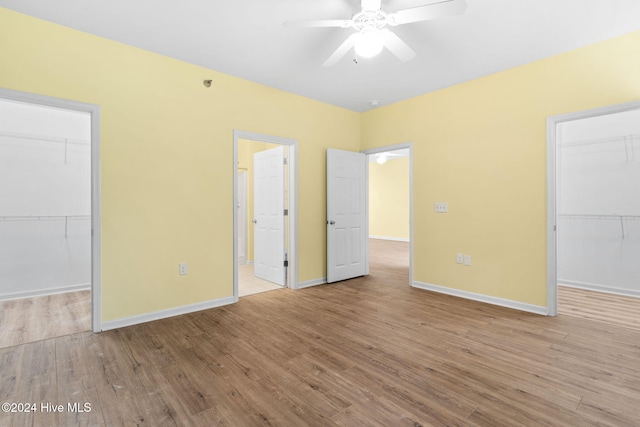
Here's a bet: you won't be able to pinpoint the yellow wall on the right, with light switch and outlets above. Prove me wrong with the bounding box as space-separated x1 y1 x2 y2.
362 32 640 306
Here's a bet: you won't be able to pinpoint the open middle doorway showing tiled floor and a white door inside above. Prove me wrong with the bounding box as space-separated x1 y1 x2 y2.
234 131 297 301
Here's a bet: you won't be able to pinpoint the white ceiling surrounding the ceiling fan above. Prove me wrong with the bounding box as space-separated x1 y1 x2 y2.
0 0 640 111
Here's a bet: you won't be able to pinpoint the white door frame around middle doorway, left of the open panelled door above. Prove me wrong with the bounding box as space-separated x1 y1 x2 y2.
233 129 298 302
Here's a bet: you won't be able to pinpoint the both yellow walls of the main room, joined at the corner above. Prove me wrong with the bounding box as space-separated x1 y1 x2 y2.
0 4 640 321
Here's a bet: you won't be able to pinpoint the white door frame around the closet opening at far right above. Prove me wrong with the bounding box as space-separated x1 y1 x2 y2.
547 101 640 316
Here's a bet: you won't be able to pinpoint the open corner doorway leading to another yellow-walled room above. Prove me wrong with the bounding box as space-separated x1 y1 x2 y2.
364 143 413 286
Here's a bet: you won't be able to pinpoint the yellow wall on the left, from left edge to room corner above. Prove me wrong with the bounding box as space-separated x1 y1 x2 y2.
0 8 360 321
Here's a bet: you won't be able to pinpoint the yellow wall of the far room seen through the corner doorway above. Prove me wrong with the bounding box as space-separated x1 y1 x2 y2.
369 157 409 240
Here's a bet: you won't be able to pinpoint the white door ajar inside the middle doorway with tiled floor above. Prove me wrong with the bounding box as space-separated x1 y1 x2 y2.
253 146 285 286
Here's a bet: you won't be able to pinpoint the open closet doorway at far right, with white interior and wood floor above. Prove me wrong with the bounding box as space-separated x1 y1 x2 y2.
548 102 640 320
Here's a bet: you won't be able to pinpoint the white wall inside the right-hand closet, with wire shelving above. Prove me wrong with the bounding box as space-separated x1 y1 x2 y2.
557 111 640 296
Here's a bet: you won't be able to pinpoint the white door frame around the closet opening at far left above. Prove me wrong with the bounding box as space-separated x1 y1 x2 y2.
0 88 102 332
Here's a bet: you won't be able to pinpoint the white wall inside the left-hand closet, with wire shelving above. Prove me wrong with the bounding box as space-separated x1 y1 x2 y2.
0 99 91 299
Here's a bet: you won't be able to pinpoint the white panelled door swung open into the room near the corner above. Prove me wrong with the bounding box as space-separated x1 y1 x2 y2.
327 148 367 283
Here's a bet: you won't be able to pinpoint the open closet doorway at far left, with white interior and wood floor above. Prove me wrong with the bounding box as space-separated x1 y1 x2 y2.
0 90 100 346
